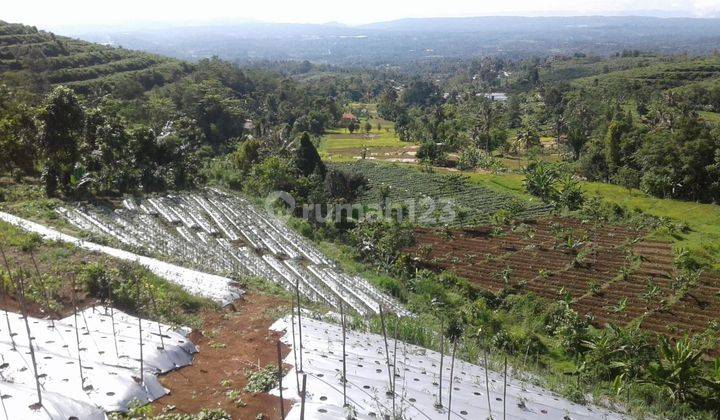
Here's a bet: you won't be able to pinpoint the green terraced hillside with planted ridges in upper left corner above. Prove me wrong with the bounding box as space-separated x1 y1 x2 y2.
0 21 190 94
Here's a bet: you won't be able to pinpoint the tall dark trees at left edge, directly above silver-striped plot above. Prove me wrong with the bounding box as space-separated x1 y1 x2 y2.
6 87 204 196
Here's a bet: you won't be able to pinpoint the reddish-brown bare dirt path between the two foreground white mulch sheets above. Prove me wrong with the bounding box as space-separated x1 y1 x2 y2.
153 294 291 419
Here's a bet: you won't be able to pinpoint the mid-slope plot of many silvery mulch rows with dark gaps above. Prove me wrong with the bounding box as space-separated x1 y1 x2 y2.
58 190 404 315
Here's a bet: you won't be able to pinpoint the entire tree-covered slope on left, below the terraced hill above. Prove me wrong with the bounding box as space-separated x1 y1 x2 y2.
0 54 352 196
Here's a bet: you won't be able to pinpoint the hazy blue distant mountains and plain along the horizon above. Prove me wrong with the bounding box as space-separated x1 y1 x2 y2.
56 16 720 66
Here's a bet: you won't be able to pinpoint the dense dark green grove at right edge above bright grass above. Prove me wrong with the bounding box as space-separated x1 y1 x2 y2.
565 96 720 202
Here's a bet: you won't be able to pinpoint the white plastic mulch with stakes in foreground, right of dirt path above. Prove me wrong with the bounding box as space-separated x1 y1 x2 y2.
271 317 622 420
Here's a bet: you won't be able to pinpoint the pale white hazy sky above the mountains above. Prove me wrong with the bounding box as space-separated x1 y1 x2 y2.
5 0 720 28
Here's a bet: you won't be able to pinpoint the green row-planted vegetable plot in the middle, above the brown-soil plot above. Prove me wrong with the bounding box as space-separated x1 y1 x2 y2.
333 161 550 226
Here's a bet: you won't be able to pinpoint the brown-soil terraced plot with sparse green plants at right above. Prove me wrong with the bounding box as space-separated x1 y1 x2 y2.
407 219 720 337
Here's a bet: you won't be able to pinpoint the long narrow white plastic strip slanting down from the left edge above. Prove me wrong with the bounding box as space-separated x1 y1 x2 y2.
0 212 242 305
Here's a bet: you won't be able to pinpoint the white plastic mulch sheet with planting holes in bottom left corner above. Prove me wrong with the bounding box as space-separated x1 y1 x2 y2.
0 307 197 419
